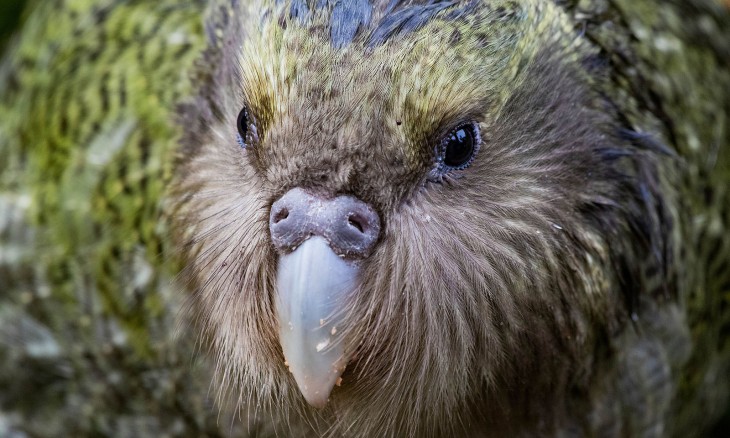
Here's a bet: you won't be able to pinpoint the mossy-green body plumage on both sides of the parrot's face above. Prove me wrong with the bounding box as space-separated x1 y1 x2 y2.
0 0 730 436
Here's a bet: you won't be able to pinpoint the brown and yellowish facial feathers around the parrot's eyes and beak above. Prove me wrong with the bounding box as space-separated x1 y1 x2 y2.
173 2 700 436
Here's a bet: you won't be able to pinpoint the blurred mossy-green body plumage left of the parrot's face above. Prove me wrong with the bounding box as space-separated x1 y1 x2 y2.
0 1 236 436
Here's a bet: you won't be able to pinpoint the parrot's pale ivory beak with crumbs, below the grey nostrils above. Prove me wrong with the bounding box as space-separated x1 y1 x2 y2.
276 236 358 408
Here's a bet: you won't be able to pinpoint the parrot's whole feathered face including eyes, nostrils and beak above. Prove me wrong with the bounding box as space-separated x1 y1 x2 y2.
173 1 636 436
